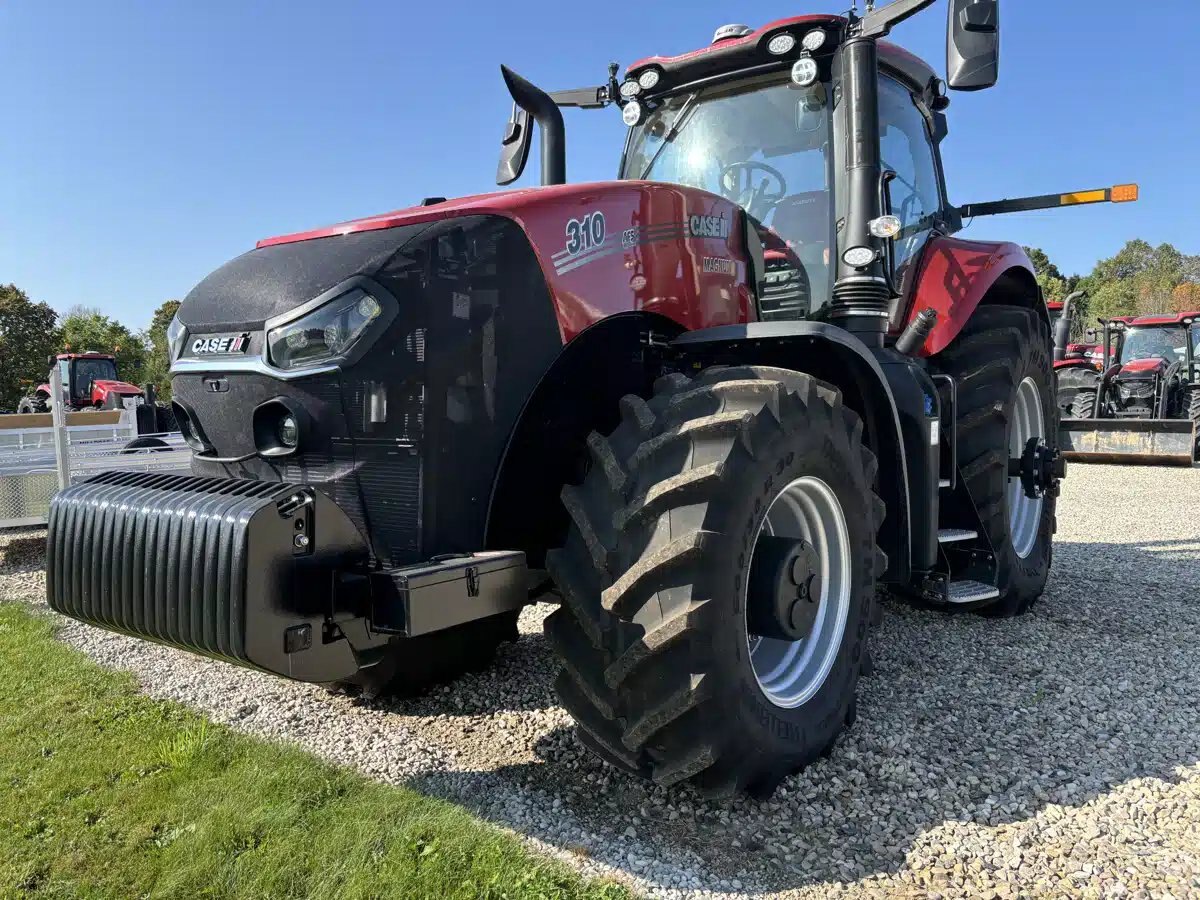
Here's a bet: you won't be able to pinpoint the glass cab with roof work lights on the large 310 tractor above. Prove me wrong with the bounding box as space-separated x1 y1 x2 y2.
619 16 946 320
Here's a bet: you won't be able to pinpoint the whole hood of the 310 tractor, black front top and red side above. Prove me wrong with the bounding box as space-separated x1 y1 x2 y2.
173 180 752 340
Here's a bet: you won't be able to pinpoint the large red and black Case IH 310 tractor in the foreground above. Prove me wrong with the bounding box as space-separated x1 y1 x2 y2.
47 0 1133 796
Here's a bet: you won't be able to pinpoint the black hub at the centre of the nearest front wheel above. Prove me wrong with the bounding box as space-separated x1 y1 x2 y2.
746 535 822 641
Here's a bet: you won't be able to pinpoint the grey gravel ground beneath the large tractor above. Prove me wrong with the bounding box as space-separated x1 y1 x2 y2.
7 466 1200 898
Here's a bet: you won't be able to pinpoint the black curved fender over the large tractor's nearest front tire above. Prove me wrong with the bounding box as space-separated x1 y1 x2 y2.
672 322 940 584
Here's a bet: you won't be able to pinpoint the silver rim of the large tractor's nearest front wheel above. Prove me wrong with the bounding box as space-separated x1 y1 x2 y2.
743 476 851 709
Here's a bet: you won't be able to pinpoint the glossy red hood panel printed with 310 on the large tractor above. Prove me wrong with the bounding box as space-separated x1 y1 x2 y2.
258 181 755 341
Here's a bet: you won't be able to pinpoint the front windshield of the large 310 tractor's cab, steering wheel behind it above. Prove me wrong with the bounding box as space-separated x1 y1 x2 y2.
620 72 834 307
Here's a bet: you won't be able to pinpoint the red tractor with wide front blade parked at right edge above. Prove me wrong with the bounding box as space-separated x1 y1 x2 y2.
1060 311 1200 466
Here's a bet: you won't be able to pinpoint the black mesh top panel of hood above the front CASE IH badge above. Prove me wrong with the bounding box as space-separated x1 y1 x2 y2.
179 222 431 331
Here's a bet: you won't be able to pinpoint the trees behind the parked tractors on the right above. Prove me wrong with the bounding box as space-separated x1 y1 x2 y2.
1025 240 1200 337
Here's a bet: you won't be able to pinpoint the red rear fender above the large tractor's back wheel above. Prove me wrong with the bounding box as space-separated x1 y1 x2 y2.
892 235 1050 356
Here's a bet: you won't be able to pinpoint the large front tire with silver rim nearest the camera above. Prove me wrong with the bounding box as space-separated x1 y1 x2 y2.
546 366 887 797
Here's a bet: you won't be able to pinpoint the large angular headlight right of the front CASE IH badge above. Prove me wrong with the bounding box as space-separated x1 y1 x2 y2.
266 288 383 368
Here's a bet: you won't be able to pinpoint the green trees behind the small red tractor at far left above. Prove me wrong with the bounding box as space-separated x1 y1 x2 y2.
0 284 179 412
